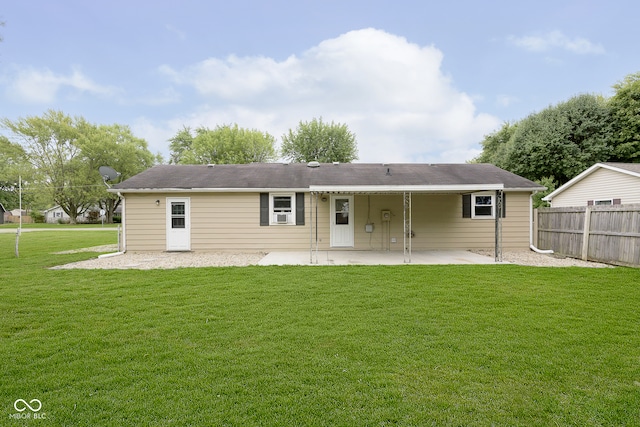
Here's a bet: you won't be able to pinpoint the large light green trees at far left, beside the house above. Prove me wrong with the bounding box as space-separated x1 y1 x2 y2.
0 110 160 223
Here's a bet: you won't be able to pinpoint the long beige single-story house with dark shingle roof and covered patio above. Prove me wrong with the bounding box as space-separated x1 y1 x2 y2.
109 162 544 258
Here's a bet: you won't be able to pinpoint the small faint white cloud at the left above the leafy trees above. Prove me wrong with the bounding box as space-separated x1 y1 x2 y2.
7 67 118 104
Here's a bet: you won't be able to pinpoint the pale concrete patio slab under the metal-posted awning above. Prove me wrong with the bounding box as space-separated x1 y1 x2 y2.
258 251 496 265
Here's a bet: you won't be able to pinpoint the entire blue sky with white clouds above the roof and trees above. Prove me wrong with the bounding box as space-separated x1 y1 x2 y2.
0 0 640 162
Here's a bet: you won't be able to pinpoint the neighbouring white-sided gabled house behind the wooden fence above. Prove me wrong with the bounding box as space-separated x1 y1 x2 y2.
542 163 640 208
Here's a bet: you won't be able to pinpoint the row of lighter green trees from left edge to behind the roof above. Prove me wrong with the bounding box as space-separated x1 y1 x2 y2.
0 110 357 223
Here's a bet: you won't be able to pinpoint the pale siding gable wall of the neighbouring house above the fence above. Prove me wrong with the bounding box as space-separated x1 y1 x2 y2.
551 168 640 208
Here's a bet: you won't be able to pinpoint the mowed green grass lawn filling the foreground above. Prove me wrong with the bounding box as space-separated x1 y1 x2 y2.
0 231 640 426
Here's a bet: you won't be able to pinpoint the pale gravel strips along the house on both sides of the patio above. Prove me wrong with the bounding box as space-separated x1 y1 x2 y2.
51 245 613 270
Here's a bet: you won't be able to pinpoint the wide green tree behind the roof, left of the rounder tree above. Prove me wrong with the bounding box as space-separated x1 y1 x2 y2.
179 124 276 164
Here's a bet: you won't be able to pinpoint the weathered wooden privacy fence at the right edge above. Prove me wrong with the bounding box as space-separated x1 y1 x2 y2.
537 204 640 267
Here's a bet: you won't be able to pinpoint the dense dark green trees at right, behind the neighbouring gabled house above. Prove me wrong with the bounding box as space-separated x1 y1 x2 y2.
473 73 640 205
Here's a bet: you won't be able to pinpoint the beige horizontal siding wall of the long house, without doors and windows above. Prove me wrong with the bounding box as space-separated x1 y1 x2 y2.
124 193 530 252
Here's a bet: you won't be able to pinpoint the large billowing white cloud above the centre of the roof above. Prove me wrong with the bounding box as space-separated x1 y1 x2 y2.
158 29 500 162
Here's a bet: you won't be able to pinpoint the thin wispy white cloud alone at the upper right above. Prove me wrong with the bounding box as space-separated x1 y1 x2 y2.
508 31 605 55
